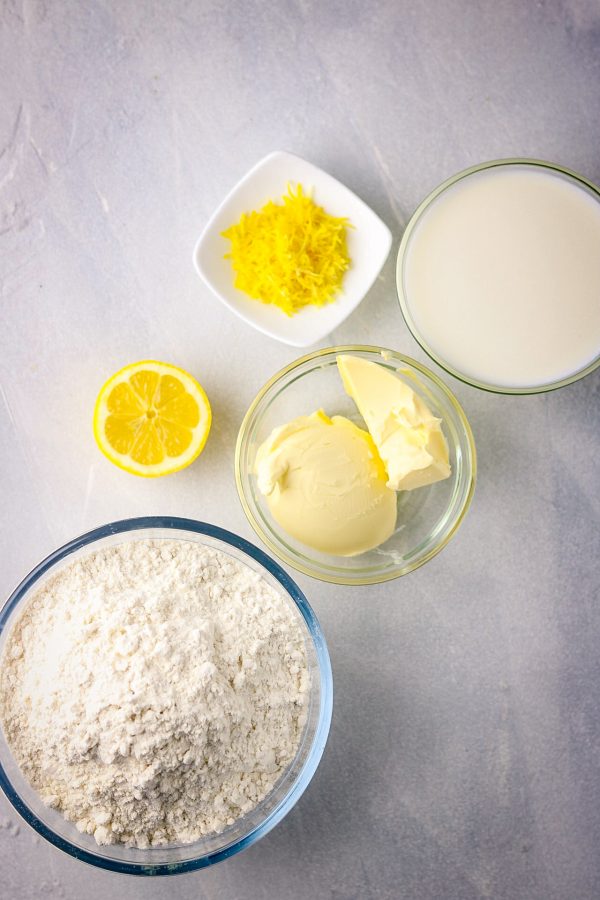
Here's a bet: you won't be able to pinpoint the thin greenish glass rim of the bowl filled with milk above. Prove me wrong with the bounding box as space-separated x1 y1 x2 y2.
396 156 600 396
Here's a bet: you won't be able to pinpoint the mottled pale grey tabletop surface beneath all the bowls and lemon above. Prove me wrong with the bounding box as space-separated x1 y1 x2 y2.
0 0 600 900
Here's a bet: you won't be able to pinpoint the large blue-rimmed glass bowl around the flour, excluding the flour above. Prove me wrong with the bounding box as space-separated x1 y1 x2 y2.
0 516 333 875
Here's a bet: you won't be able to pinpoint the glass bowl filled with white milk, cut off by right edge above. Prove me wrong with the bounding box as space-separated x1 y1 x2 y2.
396 159 600 394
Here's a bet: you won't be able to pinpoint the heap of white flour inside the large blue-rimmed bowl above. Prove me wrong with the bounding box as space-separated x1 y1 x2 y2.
0 540 309 848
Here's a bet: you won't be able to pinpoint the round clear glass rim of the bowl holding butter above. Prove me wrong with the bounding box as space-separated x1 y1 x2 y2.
234 344 477 586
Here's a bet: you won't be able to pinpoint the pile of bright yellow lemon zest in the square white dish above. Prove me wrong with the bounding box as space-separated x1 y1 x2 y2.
222 184 352 316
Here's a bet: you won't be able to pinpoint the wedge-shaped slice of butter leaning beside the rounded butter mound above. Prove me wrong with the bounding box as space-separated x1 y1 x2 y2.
337 356 450 491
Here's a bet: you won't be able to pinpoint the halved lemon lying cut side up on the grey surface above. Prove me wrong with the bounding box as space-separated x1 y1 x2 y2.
94 360 212 478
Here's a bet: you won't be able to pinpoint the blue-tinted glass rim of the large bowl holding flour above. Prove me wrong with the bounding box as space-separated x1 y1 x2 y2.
0 516 333 876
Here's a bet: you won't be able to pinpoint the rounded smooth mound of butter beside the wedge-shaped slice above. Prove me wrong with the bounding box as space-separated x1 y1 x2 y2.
256 410 396 556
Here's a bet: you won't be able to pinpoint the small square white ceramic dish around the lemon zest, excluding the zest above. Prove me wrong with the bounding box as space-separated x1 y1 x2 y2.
194 151 392 347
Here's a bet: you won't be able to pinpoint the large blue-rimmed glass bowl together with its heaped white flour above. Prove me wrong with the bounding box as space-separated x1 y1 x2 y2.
0 517 332 875
